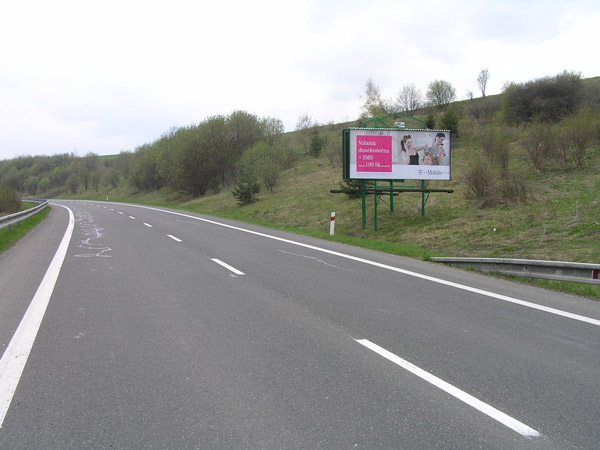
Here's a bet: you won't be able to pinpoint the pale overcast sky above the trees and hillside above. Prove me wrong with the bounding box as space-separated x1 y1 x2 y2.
0 0 600 160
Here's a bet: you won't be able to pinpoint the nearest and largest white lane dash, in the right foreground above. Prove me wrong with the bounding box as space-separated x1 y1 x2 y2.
355 339 543 438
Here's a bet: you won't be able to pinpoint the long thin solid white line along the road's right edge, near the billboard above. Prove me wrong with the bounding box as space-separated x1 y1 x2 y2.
86 203 600 326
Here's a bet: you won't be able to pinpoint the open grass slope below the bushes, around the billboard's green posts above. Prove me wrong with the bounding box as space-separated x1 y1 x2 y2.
62 118 600 297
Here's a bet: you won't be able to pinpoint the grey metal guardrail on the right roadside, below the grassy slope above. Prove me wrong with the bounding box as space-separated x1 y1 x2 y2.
431 257 600 284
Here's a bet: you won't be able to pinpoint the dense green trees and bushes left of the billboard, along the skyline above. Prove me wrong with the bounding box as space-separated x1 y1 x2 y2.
0 111 328 204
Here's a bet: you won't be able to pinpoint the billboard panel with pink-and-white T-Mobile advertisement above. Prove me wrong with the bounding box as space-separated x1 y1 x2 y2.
343 128 451 180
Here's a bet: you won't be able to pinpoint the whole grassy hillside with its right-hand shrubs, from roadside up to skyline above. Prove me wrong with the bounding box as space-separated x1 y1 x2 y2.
56 72 600 297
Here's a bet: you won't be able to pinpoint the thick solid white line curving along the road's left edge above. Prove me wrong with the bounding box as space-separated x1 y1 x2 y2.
0 203 75 428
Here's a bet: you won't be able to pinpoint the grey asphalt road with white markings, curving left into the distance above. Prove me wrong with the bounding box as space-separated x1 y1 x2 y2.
0 201 600 449
